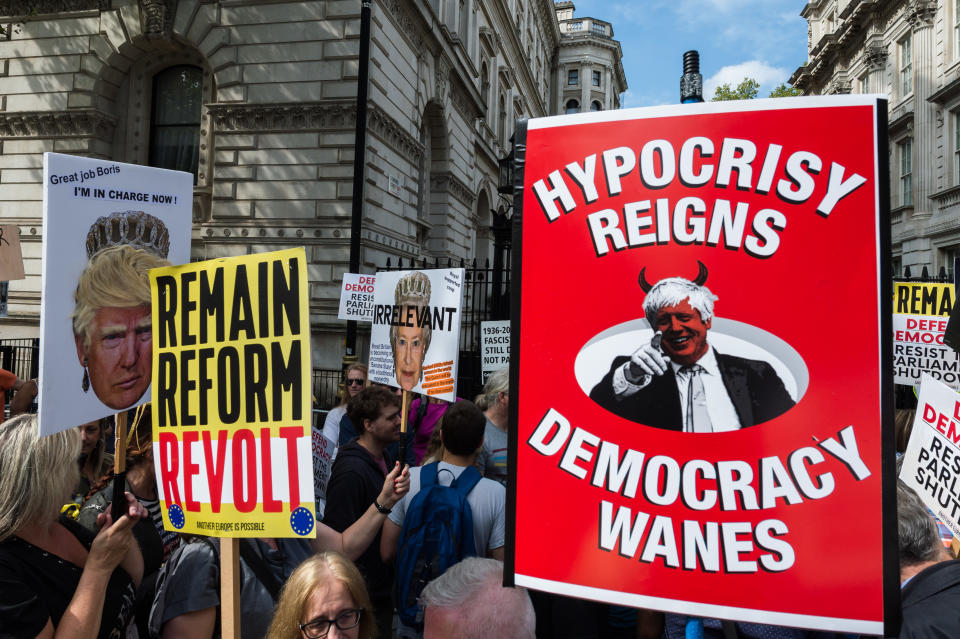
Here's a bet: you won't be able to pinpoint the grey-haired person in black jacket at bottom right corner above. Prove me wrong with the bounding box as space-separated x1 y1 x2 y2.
897 481 960 639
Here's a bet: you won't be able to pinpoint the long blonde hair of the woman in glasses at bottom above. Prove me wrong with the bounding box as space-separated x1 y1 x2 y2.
267 551 377 639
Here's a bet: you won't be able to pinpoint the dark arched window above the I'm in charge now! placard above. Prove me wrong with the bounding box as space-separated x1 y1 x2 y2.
149 65 203 182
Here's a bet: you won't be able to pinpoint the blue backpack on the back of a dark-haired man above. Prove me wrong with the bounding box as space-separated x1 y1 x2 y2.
393 462 480 630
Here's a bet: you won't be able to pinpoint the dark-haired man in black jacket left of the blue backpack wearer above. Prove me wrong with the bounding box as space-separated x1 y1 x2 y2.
323 386 400 637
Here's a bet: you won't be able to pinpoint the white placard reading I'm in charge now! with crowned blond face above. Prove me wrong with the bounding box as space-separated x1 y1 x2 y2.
39 153 193 435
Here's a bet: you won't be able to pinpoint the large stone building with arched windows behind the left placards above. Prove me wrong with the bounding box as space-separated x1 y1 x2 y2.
0 0 626 368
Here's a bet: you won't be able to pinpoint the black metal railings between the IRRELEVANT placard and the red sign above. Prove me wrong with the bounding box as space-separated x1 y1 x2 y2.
382 255 510 399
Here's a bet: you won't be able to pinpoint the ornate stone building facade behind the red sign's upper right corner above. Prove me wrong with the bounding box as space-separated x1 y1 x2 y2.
791 0 960 275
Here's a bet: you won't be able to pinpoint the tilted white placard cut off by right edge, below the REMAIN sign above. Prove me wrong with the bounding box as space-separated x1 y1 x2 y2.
900 373 960 537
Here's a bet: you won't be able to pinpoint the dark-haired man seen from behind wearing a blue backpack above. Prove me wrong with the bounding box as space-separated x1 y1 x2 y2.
380 401 506 637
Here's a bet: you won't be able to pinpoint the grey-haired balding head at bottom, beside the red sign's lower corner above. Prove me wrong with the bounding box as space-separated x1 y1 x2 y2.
420 557 536 639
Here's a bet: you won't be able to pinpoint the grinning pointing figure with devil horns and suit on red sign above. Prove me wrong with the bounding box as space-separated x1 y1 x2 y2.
590 264 794 433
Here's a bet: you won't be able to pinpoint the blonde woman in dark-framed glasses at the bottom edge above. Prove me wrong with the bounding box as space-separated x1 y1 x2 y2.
267 552 377 639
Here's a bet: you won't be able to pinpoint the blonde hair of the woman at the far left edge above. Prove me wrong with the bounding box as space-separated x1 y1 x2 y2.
0 413 80 541
